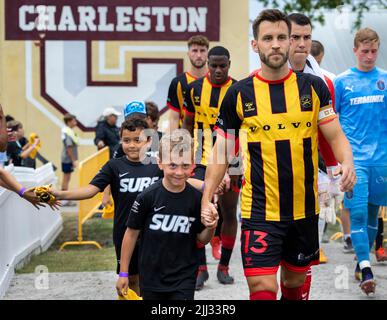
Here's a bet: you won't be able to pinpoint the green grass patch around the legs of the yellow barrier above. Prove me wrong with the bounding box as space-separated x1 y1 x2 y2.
16 213 116 273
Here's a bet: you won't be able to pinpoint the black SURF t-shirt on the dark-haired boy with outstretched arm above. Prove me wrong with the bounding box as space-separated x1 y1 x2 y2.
90 156 163 245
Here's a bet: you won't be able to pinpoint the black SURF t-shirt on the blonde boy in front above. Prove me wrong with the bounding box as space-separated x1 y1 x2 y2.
127 180 205 292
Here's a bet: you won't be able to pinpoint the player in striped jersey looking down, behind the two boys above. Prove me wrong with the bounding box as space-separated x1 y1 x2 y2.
183 46 240 290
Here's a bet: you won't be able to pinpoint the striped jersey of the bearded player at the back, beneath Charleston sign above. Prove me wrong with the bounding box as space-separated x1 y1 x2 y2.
167 72 197 127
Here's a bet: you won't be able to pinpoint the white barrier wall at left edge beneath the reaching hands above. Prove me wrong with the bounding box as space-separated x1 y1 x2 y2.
0 163 62 299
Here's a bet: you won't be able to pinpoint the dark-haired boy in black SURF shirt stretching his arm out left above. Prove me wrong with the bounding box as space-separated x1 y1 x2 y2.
52 117 162 293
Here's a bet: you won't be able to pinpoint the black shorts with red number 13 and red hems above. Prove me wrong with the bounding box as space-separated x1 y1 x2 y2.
241 215 320 277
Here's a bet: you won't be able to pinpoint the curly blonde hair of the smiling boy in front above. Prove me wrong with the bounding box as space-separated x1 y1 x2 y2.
159 129 193 163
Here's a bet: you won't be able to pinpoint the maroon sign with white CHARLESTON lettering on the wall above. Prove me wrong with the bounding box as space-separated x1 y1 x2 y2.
5 0 220 41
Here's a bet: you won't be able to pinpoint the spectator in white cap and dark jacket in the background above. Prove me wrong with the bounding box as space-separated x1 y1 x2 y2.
94 108 121 158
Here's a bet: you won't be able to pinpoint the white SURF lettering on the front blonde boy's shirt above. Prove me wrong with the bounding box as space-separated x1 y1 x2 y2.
149 213 196 233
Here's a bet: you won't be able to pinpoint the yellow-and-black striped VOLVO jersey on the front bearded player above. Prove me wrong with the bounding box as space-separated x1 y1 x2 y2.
216 71 336 224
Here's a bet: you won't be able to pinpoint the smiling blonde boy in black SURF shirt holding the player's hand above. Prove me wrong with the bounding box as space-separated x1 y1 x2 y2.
116 129 218 300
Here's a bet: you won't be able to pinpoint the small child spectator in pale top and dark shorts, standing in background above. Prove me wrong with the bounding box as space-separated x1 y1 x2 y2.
61 113 78 206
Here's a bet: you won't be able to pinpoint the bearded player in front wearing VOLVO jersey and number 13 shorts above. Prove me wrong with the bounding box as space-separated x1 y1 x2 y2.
202 9 356 300
